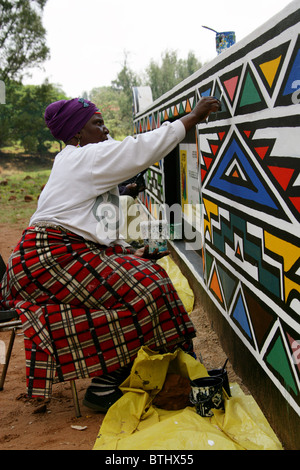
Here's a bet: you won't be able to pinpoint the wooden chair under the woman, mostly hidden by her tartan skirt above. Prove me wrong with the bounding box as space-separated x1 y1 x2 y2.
0 255 81 418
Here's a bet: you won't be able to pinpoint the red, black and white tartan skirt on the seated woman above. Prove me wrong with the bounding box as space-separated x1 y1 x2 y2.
0 227 195 397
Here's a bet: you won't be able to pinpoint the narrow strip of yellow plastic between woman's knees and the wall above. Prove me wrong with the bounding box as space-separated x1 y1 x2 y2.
157 256 195 314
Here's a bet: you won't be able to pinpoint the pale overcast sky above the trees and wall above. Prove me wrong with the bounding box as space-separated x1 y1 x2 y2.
24 0 291 97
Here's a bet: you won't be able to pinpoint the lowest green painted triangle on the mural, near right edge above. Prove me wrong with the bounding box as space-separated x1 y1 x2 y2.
266 336 299 395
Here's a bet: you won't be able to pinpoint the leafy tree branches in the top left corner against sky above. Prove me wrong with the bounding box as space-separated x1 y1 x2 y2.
0 0 49 82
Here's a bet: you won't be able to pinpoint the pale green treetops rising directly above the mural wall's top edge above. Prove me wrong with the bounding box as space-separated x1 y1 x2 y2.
146 50 202 100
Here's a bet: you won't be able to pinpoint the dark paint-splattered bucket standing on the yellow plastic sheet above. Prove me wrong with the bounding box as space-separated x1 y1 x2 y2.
190 377 224 417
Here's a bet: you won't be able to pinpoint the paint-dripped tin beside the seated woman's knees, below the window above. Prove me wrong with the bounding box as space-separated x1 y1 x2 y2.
140 220 169 253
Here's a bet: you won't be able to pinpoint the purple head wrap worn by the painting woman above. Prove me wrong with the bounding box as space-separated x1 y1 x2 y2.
45 98 99 142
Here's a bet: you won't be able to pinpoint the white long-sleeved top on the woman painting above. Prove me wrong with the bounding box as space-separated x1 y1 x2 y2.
30 120 186 246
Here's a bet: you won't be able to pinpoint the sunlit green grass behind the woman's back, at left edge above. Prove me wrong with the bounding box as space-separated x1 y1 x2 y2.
0 165 50 224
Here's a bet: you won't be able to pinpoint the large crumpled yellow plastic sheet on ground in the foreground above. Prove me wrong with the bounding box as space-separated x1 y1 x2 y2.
94 347 282 450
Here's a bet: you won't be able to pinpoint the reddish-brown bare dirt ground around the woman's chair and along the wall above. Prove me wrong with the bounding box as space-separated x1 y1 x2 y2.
0 221 247 450
